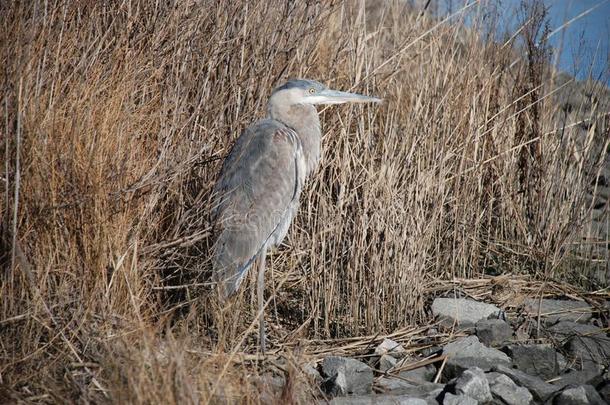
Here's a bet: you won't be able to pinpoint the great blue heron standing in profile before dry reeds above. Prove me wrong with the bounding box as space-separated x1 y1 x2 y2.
212 79 381 352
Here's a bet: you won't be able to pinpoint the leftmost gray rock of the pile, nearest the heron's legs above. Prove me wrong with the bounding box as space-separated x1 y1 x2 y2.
322 356 373 395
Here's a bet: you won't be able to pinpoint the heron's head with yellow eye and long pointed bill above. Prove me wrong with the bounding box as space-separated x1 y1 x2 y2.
270 79 381 105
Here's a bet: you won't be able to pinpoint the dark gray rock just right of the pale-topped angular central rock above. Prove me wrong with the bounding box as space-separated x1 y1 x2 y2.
504 344 559 379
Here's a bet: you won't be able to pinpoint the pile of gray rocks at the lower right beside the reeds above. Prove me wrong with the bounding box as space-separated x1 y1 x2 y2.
308 298 610 405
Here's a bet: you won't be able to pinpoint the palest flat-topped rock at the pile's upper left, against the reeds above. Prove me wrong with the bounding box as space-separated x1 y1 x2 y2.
432 298 500 327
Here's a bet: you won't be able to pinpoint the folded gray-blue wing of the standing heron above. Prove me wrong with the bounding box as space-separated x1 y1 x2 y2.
213 120 300 297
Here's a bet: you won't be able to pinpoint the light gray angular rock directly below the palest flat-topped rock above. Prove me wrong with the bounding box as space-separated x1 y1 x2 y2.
443 336 510 378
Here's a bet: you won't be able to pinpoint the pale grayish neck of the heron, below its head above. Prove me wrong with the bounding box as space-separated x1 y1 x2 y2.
268 103 322 174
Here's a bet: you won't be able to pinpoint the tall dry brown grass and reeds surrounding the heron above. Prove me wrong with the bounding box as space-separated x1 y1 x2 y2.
0 0 610 403
